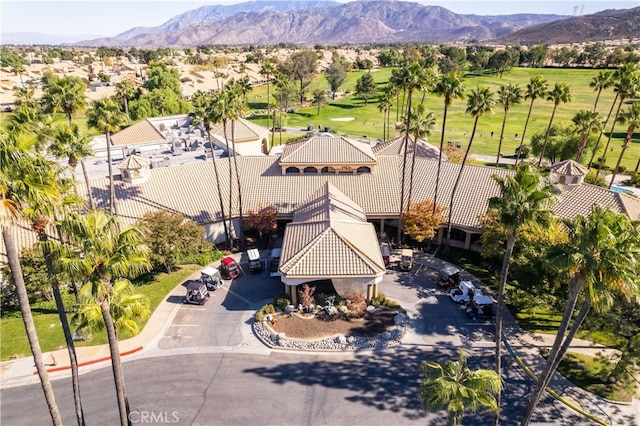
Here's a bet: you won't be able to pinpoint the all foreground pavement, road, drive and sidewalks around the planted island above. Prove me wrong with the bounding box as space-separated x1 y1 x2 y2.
0 254 639 425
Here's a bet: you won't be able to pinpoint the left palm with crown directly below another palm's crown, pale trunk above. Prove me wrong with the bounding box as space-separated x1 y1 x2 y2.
47 124 94 210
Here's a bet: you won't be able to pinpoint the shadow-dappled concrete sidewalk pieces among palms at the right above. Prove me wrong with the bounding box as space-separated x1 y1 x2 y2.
417 255 640 424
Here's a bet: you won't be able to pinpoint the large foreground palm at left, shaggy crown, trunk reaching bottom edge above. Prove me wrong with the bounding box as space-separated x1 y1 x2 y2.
57 210 151 425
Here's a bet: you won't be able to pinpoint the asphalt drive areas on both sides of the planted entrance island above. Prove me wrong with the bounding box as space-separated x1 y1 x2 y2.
158 256 493 349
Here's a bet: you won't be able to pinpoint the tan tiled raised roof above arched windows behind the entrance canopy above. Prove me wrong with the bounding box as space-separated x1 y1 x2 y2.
280 137 376 165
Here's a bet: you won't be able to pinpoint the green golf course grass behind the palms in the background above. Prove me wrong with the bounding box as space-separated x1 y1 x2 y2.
248 68 640 168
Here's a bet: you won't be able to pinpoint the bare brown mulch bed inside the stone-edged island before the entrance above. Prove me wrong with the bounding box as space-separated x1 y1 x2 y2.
270 309 397 339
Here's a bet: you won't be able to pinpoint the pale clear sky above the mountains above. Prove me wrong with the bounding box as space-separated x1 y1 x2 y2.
0 0 640 36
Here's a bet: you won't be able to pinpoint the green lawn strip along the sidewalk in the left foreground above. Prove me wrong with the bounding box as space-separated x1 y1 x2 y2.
0 265 196 361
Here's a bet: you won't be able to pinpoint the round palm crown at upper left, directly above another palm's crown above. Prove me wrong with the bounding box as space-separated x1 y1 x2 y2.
43 76 87 124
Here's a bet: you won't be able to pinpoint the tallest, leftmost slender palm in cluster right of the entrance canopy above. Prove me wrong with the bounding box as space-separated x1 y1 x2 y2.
398 61 434 245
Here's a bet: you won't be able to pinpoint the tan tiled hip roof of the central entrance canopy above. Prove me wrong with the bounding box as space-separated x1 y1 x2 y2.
280 182 385 278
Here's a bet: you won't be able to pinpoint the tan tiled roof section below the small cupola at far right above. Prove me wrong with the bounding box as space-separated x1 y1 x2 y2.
554 184 640 220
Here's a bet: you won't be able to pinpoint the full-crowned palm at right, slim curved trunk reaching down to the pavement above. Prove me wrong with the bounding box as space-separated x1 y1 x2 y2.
489 162 553 424
